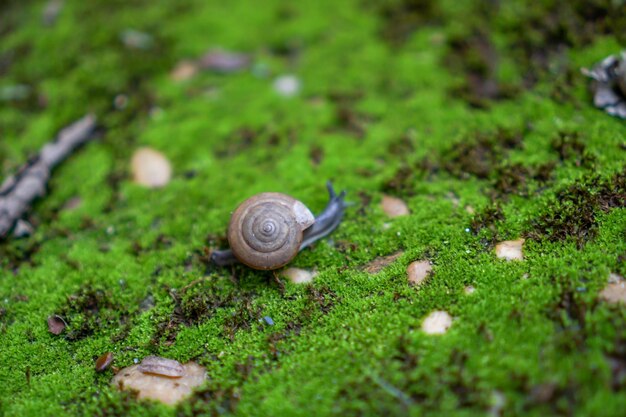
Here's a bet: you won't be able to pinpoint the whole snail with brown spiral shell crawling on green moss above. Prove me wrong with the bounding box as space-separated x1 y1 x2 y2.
211 181 346 270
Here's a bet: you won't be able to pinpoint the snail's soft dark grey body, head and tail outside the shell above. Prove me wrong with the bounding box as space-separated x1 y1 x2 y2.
211 181 347 266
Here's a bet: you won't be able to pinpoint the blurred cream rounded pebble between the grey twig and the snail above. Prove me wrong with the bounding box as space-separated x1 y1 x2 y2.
131 148 172 188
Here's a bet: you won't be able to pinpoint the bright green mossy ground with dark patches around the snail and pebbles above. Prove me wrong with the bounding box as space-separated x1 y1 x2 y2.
0 0 626 416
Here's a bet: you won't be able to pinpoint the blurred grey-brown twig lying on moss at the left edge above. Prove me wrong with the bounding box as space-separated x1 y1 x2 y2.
0 114 96 238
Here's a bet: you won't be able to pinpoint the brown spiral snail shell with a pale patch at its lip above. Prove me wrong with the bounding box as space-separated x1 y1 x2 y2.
228 193 315 270
